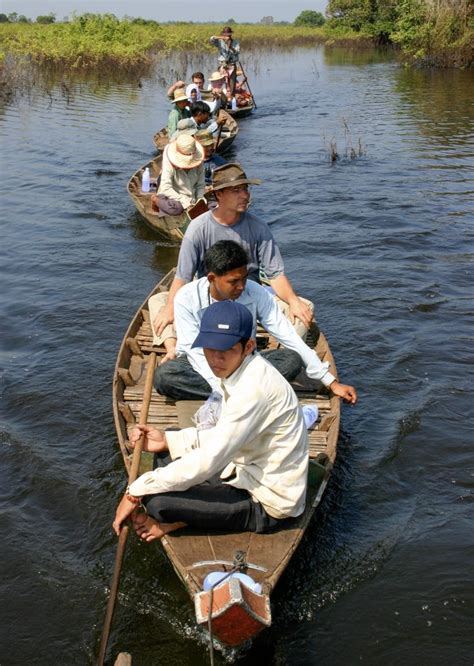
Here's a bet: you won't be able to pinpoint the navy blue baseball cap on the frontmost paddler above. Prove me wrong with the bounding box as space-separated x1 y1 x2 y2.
192 301 253 351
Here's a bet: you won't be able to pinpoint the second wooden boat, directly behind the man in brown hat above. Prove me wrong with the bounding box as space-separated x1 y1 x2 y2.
127 155 207 243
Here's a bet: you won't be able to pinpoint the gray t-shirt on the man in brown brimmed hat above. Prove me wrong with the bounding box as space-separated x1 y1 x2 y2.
176 211 285 282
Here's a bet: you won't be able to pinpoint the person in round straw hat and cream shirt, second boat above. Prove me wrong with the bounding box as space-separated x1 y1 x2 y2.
151 134 205 215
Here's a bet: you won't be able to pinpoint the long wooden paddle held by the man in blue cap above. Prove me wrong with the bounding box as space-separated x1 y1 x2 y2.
97 352 156 666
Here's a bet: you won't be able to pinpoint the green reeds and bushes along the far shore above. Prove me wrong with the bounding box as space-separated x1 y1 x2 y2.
0 10 474 79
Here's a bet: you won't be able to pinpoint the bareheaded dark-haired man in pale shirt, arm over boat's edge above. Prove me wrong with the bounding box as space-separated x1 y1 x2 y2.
148 240 357 404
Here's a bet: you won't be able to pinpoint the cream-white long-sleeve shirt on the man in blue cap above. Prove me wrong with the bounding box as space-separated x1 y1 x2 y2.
129 355 308 518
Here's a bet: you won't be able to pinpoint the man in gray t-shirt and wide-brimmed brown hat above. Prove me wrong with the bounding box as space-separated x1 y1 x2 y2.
153 163 313 334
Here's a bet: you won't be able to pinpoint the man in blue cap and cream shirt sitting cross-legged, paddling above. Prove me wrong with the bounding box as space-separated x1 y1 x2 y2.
113 301 308 541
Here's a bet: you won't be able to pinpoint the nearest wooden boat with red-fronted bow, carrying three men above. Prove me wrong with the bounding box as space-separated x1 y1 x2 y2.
113 271 340 645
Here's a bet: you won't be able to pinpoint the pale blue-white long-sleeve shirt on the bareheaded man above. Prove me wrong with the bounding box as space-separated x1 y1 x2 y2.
174 277 336 391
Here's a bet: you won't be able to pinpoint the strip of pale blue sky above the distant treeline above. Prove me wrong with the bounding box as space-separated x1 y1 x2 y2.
0 0 327 23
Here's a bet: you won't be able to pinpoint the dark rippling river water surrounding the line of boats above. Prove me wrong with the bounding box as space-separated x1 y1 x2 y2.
0 48 474 666
